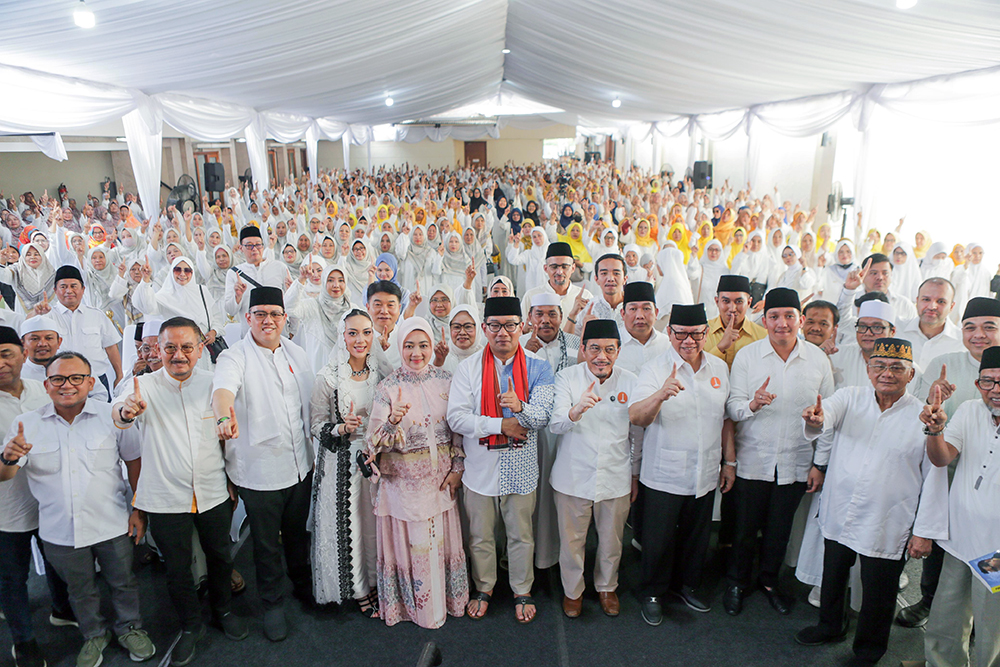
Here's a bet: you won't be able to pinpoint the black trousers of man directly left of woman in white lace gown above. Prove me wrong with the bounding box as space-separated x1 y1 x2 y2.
239 471 313 609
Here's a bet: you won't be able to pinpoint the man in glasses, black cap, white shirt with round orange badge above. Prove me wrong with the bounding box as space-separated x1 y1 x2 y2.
629 303 737 625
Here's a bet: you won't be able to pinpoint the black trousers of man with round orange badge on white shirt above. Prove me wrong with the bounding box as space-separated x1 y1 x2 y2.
639 484 715 597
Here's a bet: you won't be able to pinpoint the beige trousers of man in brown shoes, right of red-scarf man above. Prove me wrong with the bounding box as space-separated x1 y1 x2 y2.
555 491 630 600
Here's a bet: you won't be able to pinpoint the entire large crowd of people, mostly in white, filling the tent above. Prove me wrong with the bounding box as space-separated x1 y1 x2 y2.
0 162 1000 667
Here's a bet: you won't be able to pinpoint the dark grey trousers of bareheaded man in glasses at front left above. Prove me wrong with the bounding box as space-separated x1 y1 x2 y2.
45 535 142 640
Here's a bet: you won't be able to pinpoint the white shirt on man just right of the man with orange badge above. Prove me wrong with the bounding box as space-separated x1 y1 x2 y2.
727 338 833 484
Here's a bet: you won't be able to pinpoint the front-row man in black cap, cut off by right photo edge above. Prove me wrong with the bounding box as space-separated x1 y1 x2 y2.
918 347 1000 667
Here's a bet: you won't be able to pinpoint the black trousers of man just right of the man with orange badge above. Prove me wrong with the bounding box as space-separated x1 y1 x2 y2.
726 477 806 588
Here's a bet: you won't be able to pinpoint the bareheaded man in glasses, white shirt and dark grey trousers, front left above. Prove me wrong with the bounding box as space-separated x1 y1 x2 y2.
0 352 156 667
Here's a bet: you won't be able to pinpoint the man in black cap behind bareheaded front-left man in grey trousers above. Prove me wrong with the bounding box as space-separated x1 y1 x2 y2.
34 266 122 401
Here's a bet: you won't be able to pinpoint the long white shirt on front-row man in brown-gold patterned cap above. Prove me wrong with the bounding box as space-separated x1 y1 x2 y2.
802 384 948 559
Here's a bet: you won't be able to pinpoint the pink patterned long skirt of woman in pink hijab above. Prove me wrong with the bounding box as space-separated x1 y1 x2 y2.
376 507 469 628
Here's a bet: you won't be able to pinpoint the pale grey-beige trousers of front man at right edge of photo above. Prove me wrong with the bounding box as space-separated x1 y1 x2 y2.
924 552 1000 667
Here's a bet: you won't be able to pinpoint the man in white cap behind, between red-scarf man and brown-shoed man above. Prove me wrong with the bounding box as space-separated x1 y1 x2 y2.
521 292 580 570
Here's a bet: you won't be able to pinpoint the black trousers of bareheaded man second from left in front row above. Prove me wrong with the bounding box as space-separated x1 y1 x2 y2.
147 499 233 630
